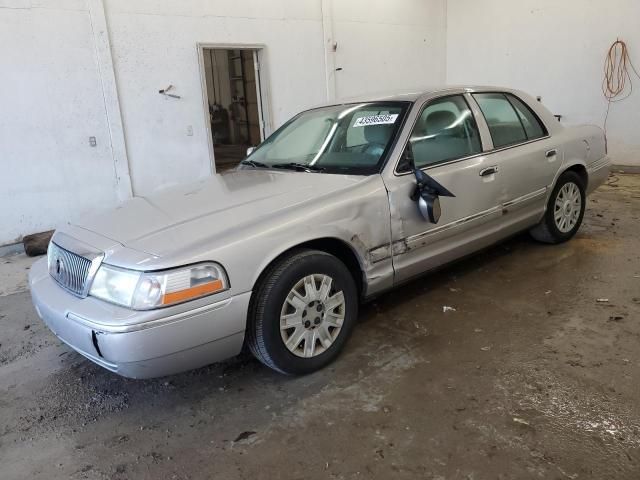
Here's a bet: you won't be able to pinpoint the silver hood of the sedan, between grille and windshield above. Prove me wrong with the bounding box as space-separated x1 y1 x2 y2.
76 169 366 257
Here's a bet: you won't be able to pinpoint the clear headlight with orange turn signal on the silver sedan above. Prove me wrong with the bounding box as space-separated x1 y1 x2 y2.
89 263 229 310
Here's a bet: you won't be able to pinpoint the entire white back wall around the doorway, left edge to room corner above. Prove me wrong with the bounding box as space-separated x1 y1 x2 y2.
0 0 445 245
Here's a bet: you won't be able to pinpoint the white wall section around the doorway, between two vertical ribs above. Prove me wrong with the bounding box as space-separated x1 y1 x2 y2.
106 0 324 195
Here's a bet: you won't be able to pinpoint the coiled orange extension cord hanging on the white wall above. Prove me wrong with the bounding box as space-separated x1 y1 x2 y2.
602 39 640 133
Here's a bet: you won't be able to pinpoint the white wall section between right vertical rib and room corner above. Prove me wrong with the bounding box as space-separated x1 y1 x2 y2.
329 0 446 98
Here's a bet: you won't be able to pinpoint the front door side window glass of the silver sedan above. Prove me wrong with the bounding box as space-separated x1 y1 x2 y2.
409 95 482 168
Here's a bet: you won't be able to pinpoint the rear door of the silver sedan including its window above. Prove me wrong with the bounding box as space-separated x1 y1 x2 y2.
472 92 562 216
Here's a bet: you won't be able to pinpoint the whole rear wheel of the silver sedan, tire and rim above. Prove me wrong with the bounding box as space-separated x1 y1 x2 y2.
529 171 586 244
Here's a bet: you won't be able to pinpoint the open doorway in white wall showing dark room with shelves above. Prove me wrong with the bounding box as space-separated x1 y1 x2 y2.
202 47 264 173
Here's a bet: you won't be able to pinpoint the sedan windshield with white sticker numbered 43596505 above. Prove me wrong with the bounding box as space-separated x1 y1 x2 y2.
242 102 409 175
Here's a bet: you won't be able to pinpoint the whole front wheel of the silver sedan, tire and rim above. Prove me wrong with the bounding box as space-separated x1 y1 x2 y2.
246 250 358 375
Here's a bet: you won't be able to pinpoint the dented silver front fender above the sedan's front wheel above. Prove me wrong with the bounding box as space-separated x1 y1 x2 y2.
206 175 393 295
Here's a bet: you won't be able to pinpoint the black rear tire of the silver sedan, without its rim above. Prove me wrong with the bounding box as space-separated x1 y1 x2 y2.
529 171 586 244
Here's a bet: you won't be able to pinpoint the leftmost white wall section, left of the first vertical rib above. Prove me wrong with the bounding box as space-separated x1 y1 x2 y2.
0 0 117 245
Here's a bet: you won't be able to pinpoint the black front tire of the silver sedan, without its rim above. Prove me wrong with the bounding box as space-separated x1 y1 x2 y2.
246 249 358 375
